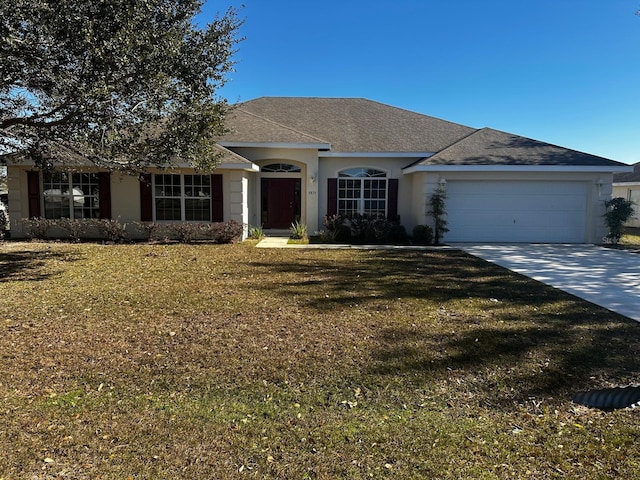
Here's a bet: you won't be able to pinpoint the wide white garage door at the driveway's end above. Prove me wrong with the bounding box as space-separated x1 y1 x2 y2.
444 181 587 243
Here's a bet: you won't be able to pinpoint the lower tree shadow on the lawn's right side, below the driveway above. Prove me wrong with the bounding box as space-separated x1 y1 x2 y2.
370 310 640 408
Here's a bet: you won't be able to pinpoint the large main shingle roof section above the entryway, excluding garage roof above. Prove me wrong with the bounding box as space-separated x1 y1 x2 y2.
220 97 475 153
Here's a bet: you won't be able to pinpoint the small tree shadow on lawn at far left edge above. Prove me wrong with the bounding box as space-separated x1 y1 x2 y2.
0 250 75 282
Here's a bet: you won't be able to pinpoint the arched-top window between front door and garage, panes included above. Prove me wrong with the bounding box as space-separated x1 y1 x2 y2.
338 168 387 217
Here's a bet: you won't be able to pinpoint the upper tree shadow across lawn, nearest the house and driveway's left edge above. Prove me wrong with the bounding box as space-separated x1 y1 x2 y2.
252 250 568 312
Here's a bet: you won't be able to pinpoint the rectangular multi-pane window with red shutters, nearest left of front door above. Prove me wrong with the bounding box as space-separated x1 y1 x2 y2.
153 174 211 222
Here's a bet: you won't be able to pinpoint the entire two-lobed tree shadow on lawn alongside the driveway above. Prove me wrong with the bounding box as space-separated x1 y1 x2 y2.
252 251 640 408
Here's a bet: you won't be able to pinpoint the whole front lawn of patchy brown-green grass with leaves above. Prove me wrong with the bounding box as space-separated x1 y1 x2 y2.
0 243 640 479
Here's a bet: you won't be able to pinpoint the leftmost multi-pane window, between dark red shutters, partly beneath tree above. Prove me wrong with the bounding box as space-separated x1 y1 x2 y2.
42 170 100 219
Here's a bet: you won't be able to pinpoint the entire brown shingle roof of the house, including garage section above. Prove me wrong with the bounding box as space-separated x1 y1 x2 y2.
220 97 622 167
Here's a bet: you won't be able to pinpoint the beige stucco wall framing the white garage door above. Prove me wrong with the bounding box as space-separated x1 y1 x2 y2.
412 171 613 243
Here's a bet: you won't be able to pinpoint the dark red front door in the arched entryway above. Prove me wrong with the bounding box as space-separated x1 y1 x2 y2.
261 178 301 229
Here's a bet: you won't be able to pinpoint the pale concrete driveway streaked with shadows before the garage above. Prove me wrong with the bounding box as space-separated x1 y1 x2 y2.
452 244 640 321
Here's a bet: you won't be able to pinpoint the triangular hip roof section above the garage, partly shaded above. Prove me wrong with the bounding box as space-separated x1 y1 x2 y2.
413 128 620 166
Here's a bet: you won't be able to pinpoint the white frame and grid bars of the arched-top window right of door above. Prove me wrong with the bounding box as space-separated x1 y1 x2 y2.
337 167 389 218
